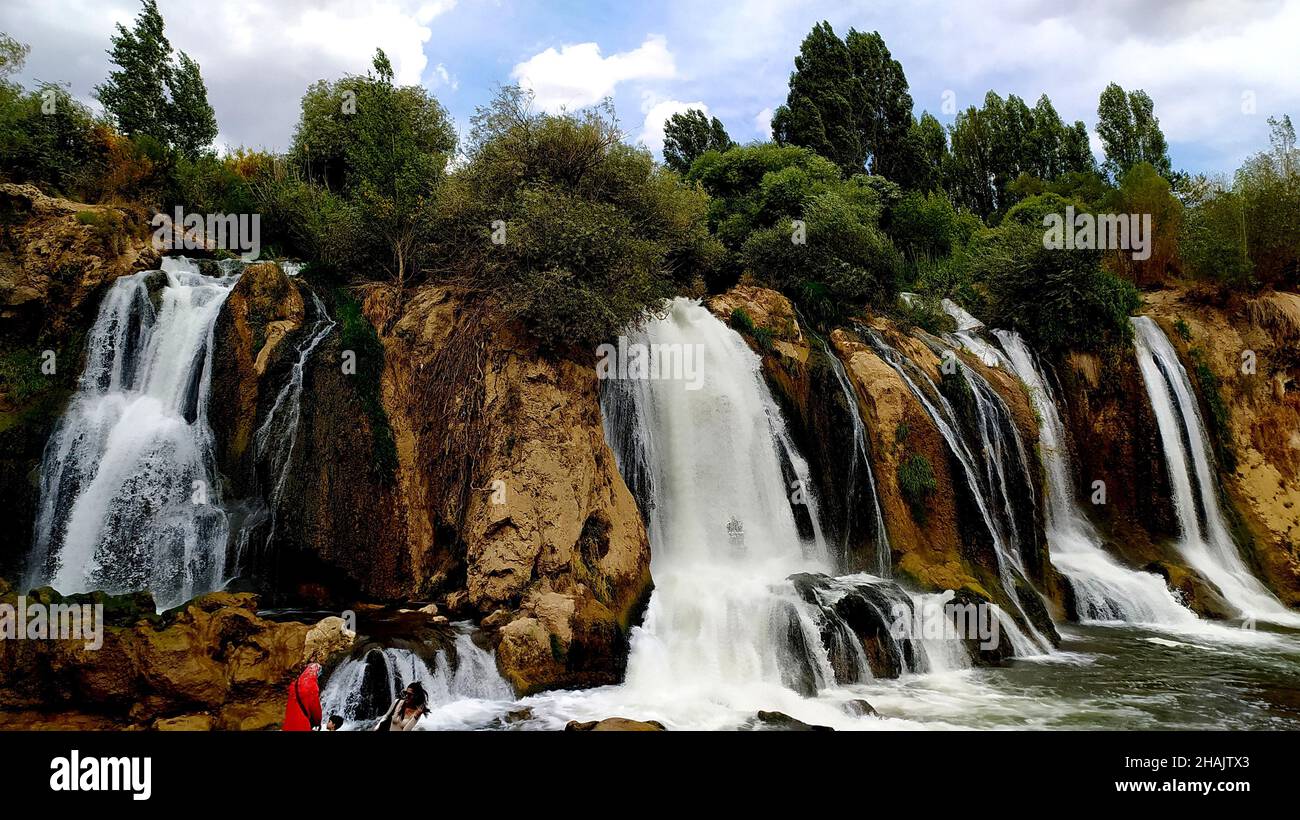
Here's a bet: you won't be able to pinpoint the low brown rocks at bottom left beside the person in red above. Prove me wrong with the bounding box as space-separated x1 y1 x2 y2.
0 593 332 730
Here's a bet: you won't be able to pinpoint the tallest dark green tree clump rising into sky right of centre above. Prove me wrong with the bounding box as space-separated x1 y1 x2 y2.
772 22 913 178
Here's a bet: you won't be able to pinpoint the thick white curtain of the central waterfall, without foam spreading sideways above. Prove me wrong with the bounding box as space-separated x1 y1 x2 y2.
605 299 833 694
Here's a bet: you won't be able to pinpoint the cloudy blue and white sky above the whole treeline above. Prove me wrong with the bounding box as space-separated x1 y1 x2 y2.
0 0 1300 174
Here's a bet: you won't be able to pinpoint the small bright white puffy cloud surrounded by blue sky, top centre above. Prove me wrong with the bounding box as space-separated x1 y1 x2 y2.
511 34 677 112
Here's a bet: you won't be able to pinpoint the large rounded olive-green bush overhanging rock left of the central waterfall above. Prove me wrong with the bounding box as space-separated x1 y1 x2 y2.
437 88 723 346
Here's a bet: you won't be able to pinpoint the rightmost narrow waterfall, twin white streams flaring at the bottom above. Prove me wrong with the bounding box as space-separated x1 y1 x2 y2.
1132 316 1300 625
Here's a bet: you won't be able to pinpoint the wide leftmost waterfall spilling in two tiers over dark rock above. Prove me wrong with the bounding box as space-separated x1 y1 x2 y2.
29 257 238 607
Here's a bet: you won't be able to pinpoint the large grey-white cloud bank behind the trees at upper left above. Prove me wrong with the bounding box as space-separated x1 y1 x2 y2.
0 0 455 148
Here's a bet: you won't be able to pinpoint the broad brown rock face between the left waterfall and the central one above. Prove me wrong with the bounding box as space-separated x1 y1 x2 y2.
283 286 650 693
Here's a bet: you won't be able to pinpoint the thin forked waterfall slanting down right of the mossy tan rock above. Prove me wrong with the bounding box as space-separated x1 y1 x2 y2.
861 326 1052 654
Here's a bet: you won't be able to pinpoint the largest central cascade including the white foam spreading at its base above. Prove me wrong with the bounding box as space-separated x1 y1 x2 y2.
524 299 969 728
